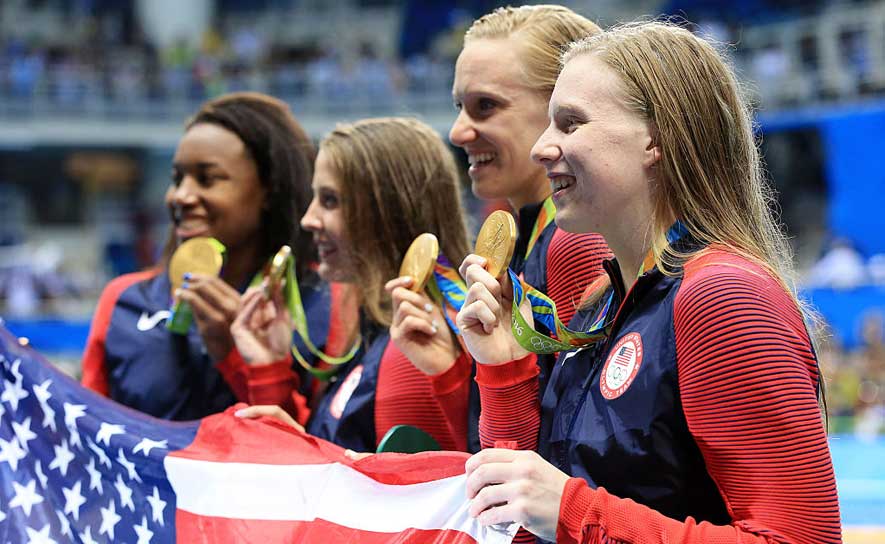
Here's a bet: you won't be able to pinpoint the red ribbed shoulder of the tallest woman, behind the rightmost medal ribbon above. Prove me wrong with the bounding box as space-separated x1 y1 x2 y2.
545 228 612 324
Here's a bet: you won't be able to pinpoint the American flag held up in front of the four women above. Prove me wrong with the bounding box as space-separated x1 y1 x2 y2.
0 325 517 544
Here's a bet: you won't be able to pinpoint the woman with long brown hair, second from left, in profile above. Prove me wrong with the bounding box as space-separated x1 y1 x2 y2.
235 118 472 452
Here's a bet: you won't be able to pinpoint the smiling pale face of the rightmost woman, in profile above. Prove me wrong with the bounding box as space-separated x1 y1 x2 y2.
532 54 660 244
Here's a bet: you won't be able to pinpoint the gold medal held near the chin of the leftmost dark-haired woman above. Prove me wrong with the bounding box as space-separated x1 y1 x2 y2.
166 237 225 334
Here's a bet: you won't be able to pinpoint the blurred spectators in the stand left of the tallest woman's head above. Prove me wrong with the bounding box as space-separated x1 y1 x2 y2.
0 6 452 115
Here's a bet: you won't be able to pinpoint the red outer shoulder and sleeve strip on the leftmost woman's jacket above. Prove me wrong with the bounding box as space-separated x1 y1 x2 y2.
80 269 160 396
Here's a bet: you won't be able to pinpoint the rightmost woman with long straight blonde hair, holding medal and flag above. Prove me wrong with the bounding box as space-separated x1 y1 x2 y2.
457 22 841 544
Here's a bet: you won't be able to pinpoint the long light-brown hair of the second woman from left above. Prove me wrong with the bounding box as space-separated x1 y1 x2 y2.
320 117 469 326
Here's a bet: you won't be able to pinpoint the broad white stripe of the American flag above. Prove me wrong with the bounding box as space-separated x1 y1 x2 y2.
165 456 518 544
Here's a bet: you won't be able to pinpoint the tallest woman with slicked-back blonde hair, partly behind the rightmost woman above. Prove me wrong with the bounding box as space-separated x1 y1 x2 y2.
449 5 611 464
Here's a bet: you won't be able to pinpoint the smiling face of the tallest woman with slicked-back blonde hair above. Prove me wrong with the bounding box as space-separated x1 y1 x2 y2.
449 38 549 209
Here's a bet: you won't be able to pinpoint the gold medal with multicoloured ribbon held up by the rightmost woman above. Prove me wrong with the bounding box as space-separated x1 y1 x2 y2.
474 202 614 353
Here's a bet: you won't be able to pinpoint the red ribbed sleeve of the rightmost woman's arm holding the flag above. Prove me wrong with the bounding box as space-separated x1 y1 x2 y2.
557 251 841 544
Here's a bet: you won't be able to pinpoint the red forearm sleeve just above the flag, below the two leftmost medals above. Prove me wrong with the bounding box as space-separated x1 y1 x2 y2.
215 348 310 425
